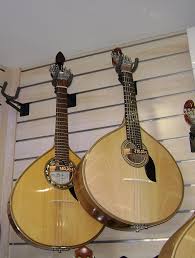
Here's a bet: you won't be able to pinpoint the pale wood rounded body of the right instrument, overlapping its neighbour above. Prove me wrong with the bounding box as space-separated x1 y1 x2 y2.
75 124 184 228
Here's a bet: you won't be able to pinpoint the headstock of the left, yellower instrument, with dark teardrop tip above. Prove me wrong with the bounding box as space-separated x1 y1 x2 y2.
49 52 73 89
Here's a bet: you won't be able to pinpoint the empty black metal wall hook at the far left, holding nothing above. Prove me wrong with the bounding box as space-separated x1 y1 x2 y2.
1 81 29 116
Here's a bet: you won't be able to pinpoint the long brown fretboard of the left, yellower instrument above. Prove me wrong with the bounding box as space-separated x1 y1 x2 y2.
55 86 69 165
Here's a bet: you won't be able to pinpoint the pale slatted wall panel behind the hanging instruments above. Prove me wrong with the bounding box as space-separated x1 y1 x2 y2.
10 34 195 258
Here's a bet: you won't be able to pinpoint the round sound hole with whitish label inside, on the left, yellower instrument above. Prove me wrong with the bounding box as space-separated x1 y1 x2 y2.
45 159 75 189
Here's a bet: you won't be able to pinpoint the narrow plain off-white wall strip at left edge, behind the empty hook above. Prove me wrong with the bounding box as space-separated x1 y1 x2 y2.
0 68 20 258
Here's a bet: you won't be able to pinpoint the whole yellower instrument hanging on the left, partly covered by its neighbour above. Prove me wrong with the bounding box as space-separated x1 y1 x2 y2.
8 53 104 250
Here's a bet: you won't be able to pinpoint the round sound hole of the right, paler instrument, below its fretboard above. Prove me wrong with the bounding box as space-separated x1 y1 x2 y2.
121 140 149 168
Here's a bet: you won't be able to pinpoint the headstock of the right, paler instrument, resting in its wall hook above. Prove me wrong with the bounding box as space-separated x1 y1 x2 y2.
111 48 139 76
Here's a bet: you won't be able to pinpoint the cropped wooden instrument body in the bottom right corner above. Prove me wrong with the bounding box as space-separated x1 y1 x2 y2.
159 216 195 258
